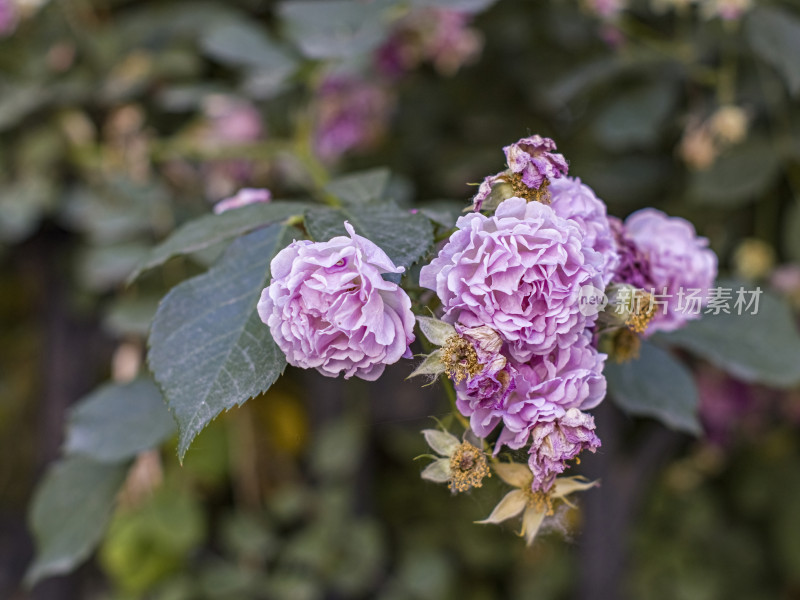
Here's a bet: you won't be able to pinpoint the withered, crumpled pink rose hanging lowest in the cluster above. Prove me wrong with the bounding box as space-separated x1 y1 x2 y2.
528 408 600 492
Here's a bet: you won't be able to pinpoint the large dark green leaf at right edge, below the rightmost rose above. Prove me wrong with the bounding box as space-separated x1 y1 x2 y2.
660 282 800 387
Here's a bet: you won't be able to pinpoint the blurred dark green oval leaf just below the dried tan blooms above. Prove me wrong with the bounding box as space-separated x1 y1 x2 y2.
689 139 780 208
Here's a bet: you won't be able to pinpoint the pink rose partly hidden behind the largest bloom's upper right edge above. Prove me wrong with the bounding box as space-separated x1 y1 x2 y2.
550 177 619 286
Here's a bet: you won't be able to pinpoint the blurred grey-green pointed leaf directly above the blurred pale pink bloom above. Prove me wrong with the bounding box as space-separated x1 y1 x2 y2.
201 20 296 77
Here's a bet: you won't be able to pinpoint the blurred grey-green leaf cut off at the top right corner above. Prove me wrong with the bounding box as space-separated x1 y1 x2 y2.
745 6 800 96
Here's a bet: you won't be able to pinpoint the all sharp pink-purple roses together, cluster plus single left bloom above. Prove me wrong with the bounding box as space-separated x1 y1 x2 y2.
258 136 716 494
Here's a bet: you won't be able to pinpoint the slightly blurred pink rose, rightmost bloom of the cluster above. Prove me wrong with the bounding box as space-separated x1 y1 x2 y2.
623 208 717 334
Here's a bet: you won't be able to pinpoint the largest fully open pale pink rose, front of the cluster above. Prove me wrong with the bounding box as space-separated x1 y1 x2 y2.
420 198 603 362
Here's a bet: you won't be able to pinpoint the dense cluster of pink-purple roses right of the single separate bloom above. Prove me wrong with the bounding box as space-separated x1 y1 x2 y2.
420 136 716 493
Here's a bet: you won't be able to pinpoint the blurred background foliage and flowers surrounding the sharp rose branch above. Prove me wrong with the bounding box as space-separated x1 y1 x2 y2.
0 0 800 600
